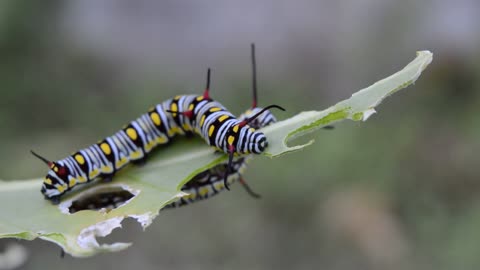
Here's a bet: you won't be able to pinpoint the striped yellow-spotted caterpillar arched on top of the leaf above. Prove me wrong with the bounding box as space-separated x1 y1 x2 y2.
31 44 284 204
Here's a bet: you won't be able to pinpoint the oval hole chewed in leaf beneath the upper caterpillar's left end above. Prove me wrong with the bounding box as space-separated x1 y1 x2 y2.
68 186 136 214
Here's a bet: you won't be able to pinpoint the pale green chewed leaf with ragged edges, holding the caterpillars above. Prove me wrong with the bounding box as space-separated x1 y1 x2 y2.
0 51 432 257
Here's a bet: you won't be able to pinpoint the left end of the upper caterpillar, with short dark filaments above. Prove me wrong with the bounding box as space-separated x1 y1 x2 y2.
31 151 70 204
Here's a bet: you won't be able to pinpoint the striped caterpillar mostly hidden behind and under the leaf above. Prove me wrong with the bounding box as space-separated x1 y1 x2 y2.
163 44 277 209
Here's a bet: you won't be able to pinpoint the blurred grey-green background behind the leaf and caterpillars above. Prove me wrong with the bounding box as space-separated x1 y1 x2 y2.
0 0 480 270
